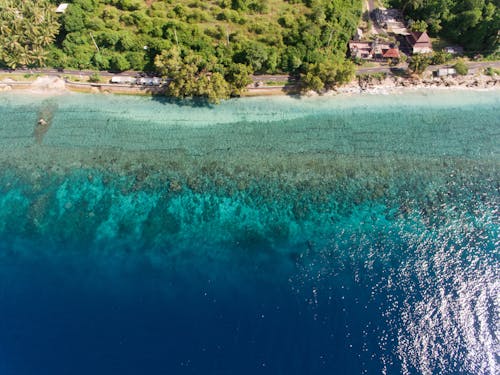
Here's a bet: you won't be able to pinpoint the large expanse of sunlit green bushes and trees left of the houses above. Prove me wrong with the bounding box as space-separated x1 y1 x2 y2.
0 0 362 100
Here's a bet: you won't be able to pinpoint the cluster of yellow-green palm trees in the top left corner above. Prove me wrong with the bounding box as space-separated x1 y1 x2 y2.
0 0 59 69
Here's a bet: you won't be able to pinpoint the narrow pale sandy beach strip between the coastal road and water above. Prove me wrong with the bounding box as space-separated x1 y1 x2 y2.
0 74 500 96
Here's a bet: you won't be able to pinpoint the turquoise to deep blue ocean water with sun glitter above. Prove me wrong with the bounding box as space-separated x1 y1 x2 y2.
0 91 500 375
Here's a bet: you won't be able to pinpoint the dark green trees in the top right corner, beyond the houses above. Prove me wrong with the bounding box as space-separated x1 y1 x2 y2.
388 0 500 54
